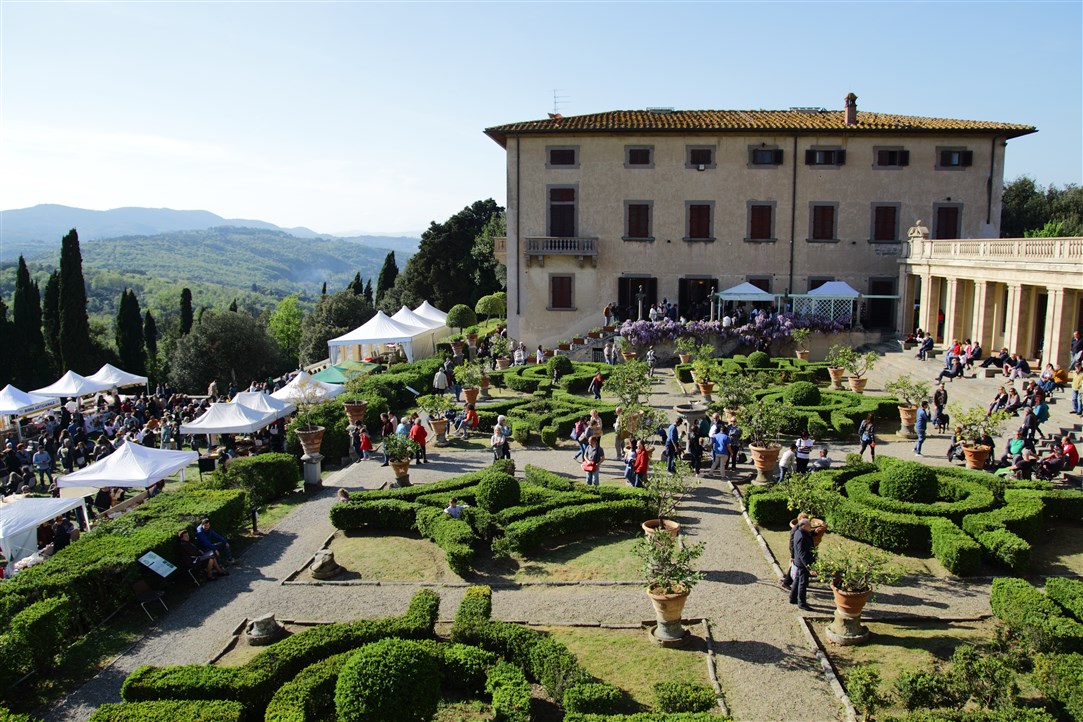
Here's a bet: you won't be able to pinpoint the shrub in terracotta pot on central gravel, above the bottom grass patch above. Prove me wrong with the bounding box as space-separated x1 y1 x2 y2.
635 534 706 645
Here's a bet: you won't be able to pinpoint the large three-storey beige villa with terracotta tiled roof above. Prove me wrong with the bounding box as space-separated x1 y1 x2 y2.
485 94 1039 347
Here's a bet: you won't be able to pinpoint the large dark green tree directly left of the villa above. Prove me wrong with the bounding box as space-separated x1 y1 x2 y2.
380 198 504 311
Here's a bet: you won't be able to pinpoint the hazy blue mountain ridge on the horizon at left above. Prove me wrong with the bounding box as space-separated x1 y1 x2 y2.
0 204 420 261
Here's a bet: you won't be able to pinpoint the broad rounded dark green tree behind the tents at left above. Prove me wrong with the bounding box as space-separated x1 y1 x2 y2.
170 310 290 393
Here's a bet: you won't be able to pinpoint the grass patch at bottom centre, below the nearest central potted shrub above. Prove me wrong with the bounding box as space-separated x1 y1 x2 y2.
540 627 710 712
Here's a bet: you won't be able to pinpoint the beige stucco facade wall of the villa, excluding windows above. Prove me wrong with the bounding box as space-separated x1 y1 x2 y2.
507 134 1004 347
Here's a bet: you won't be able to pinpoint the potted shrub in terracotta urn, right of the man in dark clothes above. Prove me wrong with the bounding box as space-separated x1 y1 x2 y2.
812 546 900 644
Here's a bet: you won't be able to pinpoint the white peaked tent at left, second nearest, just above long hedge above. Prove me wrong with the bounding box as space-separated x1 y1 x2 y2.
56 442 199 498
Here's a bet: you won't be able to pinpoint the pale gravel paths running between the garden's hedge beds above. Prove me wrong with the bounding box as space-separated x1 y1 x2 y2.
45 346 1074 722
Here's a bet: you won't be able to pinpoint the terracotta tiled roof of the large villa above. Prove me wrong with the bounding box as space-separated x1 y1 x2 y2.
485 109 1038 145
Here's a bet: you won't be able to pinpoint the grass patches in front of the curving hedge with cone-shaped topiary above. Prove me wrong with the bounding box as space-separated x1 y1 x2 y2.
302 530 640 582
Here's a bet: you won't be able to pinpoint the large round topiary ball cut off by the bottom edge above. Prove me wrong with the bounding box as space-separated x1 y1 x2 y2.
335 638 440 722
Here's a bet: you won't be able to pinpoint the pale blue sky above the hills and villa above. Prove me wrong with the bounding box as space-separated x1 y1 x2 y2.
0 0 1083 233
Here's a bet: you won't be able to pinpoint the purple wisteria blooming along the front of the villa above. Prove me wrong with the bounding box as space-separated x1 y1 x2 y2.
621 312 850 346
